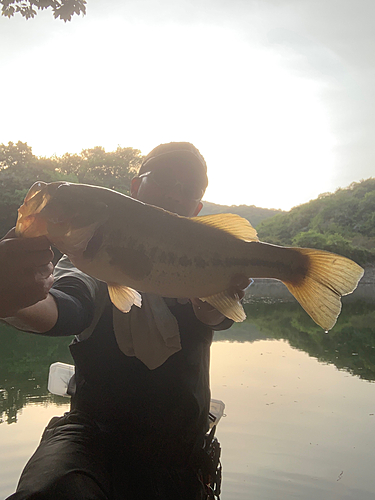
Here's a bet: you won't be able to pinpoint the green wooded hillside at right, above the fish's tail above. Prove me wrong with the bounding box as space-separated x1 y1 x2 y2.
257 177 375 265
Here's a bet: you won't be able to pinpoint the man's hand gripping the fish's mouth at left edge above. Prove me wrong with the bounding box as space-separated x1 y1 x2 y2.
0 228 53 318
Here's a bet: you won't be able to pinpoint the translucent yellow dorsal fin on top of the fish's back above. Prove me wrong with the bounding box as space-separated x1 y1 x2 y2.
192 214 259 241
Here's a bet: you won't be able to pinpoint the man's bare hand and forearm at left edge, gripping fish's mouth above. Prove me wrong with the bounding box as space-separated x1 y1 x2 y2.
0 228 57 332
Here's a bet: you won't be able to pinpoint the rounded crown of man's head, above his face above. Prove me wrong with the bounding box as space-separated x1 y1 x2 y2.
138 142 208 189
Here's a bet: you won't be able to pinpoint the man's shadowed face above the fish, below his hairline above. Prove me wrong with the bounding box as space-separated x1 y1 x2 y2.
131 160 204 217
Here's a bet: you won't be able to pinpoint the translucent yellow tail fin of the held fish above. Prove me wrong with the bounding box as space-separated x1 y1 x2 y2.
284 248 364 331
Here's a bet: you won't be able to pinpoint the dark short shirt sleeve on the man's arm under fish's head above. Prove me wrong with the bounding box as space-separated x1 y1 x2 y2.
43 257 98 337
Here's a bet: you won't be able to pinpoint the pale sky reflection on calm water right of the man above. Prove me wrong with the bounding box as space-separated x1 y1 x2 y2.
211 340 375 500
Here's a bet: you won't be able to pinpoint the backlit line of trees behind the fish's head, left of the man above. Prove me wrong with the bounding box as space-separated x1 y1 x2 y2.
0 141 142 237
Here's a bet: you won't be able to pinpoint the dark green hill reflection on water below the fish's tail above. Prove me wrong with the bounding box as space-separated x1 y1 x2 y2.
219 302 375 381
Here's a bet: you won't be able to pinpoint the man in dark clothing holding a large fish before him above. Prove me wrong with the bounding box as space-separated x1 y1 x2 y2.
3 143 249 500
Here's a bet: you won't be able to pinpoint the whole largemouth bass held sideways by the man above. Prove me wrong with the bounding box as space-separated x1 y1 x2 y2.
16 182 363 330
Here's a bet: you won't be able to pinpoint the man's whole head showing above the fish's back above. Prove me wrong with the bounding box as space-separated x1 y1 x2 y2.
131 142 208 217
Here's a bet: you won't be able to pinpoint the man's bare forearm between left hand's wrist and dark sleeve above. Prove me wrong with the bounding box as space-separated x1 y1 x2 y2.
4 294 58 333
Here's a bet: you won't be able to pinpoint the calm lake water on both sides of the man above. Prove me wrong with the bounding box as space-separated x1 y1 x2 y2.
0 303 375 500
